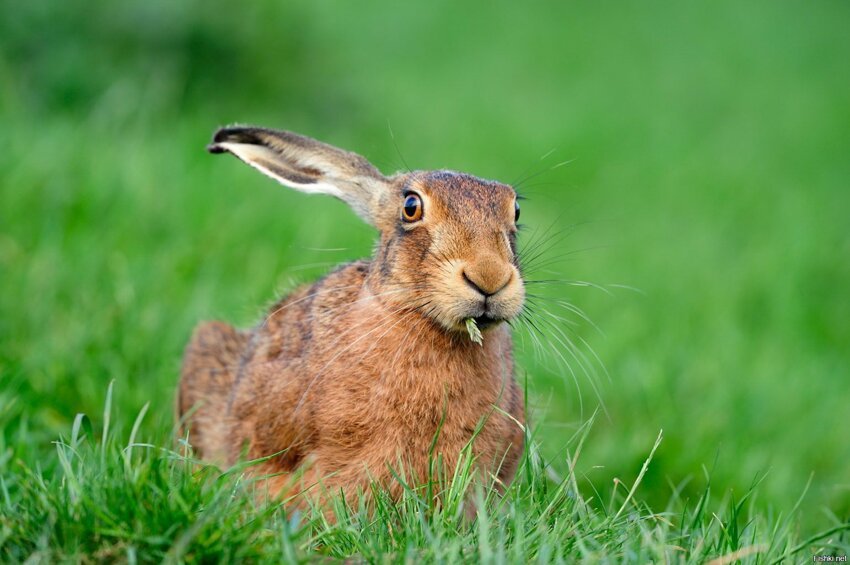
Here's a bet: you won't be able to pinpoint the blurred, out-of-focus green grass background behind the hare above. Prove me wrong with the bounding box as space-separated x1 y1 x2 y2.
0 0 850 527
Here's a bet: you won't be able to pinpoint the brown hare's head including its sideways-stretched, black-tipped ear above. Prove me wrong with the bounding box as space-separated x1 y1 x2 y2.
209 127 525 331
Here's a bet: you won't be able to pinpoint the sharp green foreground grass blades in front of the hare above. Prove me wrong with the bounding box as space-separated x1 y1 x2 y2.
0 387 850 563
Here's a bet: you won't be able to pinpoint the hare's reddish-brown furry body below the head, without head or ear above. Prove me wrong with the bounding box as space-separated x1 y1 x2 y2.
180 262 523 494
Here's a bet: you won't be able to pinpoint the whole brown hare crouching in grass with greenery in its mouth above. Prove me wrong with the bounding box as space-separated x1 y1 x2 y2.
177 126 525 504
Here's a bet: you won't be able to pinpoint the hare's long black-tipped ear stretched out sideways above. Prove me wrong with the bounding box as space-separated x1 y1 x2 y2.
207 126 390 225
